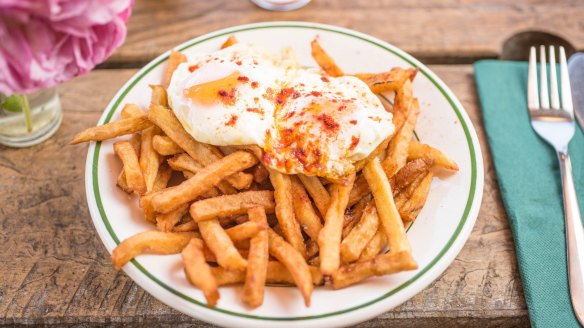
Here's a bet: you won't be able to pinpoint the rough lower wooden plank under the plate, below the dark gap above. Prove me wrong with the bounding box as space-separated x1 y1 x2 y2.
0 66 529 327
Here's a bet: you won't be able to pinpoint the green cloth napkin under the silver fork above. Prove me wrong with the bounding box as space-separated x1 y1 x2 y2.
474 60 584 328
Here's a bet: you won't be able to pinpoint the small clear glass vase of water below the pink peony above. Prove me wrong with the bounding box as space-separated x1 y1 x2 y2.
0 88 63 147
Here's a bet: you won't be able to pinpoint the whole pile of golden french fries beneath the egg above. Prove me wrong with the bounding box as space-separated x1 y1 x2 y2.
71 36 458 307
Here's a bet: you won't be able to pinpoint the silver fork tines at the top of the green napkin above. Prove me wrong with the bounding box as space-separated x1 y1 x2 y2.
527 46 573 120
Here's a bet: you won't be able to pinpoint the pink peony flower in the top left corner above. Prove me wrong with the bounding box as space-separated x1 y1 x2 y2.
0 0 134 95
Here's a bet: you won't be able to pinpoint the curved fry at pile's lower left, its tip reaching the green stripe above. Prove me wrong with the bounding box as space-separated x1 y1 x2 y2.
112 231 197 271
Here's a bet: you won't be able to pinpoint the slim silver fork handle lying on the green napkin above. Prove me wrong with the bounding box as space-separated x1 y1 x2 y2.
558 150 584 325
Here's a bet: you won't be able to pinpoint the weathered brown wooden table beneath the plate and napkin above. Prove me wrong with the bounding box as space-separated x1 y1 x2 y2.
0 0 584 327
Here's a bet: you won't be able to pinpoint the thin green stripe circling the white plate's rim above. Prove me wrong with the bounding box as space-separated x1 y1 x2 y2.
92 24 477 321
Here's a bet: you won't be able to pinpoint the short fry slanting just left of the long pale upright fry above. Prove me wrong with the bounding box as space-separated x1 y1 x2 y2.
341 202 379 263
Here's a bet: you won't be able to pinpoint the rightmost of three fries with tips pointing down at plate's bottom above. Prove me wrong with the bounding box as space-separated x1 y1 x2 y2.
268 229 314 306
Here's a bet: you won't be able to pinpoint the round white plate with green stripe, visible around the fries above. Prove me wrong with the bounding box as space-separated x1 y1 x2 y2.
85 22 483 327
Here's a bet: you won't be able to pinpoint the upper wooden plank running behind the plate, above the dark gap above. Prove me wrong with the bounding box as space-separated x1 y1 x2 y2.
106 0 584 67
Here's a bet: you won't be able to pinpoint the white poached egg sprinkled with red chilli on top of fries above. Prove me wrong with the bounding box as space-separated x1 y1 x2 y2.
168 44 394 179
